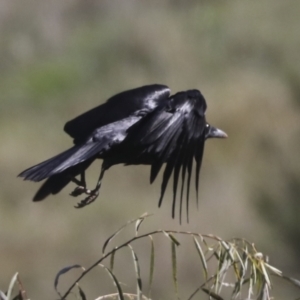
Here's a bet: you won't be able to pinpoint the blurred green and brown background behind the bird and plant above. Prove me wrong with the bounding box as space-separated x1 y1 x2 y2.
0 0 300 299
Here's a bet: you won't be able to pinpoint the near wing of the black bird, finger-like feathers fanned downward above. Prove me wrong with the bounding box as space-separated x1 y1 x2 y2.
130 91 206 218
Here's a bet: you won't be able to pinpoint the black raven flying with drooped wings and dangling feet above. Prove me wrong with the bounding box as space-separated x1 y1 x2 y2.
19 84 227 218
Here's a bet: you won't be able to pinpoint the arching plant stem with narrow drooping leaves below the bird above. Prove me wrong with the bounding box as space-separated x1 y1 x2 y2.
50 215 300 300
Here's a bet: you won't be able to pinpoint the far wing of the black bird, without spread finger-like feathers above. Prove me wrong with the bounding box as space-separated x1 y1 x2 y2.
64 84 170 144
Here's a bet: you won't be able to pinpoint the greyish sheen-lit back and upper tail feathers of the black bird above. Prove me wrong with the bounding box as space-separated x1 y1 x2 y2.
19 116 141 181
